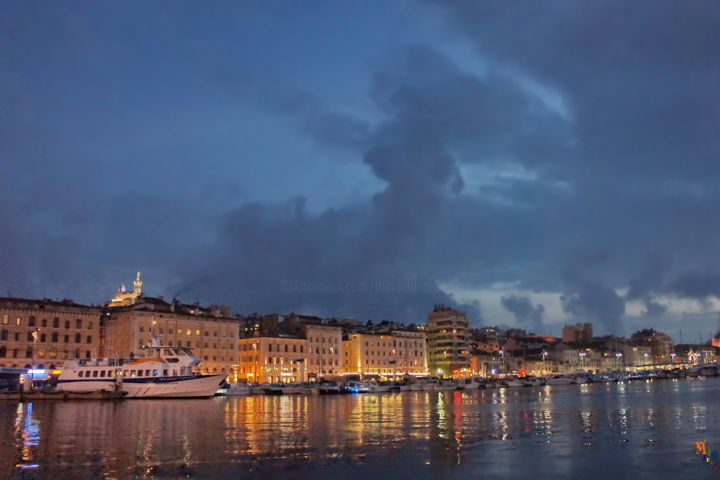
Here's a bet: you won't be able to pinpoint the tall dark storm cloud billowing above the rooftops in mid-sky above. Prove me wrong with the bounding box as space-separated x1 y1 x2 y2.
173 45 568 321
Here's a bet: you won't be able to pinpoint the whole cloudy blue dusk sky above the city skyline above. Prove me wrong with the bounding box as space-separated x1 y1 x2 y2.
0 0 720 342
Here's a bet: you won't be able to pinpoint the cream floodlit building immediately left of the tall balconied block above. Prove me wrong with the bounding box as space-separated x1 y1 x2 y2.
343 330 428 376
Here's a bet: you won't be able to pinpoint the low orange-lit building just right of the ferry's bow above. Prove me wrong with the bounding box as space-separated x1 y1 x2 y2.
238 336 309 383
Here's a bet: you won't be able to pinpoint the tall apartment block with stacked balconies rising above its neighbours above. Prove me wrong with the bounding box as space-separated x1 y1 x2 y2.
427 305 470 376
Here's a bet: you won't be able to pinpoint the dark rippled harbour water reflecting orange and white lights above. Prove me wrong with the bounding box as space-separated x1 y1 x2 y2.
0 379 720 480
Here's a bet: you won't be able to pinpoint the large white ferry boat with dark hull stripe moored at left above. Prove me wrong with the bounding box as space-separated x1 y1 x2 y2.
57 346 227 398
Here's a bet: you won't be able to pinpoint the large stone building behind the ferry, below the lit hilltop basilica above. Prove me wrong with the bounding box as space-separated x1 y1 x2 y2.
102 277 239 379
